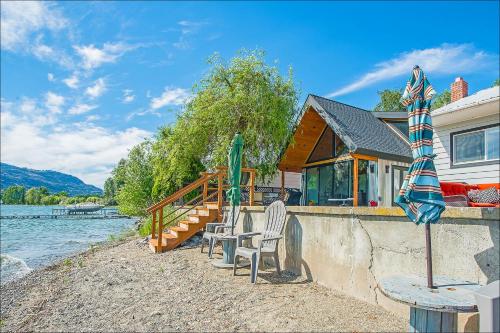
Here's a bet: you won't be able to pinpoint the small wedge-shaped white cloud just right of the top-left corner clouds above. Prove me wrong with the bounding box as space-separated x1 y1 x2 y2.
73 42 139 70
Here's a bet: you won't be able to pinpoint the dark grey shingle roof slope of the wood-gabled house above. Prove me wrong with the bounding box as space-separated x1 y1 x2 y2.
305 95 413 162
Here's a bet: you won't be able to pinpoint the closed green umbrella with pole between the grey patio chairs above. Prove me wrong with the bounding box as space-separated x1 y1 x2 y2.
227 133 243 235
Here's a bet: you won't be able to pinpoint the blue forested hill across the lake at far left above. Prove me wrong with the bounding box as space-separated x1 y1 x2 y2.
0 163 102 196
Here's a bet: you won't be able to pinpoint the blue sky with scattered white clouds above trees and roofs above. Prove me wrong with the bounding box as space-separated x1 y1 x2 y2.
1 1 500 187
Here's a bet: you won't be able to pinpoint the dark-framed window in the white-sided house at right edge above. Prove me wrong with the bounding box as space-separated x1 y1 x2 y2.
451 125 500 165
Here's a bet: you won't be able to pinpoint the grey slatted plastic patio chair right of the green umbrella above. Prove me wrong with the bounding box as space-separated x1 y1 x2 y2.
233 200 286 284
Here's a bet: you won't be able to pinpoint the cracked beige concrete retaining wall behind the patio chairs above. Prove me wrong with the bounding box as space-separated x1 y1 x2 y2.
232 207 500 326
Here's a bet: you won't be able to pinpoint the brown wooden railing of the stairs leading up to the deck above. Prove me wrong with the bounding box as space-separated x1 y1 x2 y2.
147 166 255 252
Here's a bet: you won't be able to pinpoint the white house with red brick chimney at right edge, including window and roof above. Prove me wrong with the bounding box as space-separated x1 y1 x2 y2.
432 77 500 184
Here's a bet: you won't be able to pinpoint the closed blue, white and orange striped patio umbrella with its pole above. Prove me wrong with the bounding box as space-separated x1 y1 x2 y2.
396 66 445 288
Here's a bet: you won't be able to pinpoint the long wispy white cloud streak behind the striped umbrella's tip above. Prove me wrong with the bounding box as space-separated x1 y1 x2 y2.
327 44 495 97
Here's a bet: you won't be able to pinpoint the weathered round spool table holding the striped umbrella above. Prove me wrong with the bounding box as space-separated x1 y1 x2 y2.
379 275 481 332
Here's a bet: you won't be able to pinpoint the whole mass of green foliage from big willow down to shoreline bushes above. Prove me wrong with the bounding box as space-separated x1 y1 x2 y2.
104 50 297 215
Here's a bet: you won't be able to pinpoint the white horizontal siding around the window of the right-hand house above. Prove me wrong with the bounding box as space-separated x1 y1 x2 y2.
433 114 500 184
